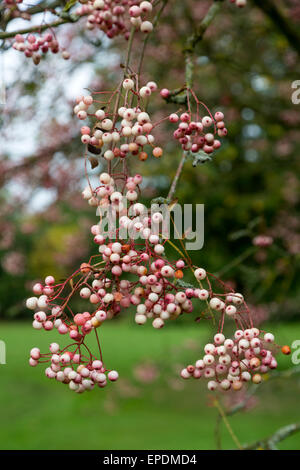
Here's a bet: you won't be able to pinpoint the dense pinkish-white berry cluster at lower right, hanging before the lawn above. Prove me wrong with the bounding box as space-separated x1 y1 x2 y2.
181 327 277 391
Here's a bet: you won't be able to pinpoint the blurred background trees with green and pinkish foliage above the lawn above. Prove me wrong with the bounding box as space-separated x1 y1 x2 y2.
0 0 300 320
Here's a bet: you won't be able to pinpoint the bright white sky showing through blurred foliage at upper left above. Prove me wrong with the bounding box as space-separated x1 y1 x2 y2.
0 10 120 212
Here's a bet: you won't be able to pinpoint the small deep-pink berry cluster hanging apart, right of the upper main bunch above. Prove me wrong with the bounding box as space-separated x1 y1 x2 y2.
169 111 227 154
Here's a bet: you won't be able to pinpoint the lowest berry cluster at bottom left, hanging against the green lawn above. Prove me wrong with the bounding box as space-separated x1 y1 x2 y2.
29 343 119 393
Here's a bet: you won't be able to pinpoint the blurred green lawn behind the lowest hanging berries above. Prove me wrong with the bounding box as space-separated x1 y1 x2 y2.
0 321 300 449
